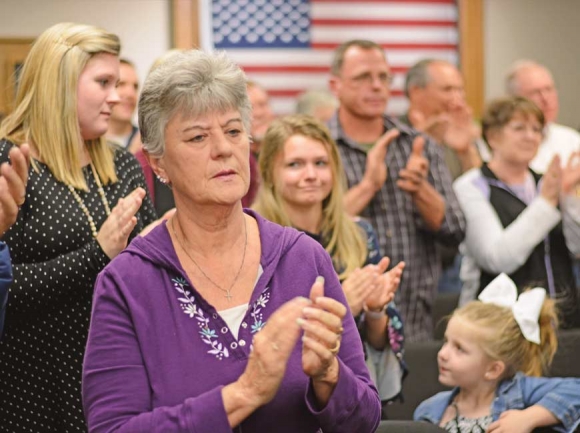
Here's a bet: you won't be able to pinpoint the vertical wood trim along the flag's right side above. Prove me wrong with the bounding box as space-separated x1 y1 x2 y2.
457 0 485 118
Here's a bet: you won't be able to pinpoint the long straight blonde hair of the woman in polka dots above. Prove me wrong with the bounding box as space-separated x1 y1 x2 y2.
0 23 121 190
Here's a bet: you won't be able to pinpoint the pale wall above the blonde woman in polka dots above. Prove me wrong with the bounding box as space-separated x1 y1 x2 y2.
0 0 171 87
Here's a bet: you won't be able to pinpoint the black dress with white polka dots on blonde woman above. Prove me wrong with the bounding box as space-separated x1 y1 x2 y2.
0 141 155 433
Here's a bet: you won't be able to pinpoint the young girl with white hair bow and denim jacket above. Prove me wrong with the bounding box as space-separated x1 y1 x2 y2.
414 274 580 433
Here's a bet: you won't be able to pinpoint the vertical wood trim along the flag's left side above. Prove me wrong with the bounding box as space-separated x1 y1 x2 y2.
170 0 199 49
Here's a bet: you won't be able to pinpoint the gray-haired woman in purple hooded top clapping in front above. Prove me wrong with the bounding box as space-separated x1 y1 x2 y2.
83 51 380 433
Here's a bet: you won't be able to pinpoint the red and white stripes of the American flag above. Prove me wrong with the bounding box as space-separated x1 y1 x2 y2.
202 0 459 114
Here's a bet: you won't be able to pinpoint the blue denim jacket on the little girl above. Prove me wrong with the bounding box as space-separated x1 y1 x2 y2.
413 373 580 432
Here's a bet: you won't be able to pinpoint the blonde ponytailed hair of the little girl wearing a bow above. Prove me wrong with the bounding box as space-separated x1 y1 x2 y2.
452 299 558 377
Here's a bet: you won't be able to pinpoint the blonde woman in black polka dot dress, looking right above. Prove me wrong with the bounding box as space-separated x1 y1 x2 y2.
0 23 155 433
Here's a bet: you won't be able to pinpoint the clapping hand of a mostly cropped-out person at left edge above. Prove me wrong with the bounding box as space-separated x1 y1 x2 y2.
0 144 30 235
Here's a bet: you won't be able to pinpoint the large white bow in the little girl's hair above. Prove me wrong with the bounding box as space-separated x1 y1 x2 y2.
478 273 546 344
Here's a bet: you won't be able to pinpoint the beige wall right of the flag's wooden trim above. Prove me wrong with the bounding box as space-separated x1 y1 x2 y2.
484 0 580 128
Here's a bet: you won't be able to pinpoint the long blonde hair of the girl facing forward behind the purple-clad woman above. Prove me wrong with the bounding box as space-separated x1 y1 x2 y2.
253 114 368 279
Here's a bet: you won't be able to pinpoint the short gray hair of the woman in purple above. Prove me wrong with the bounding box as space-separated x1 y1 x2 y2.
139 50 252 157
